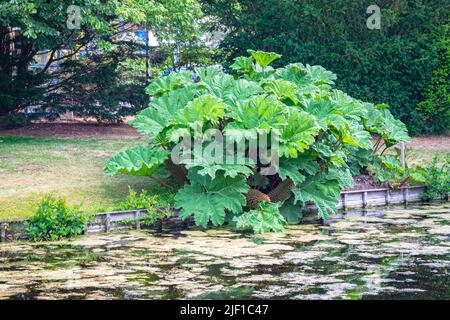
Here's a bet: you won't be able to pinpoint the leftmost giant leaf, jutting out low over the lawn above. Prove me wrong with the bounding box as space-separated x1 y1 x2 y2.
105 146 169 176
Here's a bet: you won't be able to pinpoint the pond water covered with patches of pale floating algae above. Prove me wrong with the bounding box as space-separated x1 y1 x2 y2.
0 203 450 299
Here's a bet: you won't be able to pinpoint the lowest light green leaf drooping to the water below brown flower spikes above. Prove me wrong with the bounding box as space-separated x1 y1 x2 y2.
233 202 286 233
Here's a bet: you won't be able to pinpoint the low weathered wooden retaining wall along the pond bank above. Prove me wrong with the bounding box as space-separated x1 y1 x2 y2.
0 186 425 241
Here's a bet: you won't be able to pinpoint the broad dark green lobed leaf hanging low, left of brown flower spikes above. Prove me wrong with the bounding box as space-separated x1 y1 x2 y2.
175 170 249 228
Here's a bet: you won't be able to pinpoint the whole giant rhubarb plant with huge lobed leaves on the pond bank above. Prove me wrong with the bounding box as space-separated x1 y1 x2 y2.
105 50 409 233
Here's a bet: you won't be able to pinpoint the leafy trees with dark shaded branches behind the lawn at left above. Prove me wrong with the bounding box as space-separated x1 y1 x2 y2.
0 0 201 120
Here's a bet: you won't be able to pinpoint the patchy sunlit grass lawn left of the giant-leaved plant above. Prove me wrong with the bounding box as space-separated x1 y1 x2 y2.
0 136 171 220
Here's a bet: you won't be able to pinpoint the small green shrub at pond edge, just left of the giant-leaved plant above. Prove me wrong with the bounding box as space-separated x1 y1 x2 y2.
117 188 172 225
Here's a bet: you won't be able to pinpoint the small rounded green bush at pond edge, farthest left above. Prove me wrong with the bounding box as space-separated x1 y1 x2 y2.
26 195 89 241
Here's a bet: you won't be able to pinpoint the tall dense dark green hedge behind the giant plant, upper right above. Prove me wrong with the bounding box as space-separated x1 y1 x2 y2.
204 0 450 134
